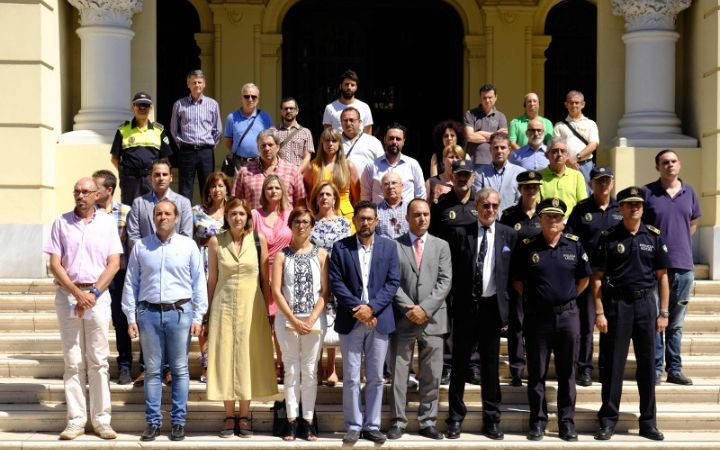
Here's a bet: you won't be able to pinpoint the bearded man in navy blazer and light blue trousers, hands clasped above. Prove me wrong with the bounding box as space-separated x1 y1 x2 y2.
330 201 400 444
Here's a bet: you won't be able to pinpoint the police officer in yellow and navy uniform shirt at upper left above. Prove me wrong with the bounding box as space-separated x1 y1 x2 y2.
110 92 175 205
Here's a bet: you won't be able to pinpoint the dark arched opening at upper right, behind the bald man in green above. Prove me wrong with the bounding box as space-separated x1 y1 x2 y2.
545 0 597 122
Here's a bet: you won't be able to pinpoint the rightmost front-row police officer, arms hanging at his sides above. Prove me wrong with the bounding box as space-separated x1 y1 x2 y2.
592 186 669 441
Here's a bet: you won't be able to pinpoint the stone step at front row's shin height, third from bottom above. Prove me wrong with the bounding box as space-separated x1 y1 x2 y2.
0 378 720 405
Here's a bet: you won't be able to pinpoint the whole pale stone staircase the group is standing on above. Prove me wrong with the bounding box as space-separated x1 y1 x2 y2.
0 273 720 450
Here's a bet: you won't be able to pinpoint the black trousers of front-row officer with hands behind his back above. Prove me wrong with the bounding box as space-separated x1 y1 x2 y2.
525 299 580 430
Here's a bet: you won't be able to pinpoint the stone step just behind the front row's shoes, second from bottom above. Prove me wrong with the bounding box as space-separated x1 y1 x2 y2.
0 402 720 434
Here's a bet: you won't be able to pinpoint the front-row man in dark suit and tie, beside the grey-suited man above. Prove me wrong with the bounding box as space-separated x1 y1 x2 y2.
447 189 517 439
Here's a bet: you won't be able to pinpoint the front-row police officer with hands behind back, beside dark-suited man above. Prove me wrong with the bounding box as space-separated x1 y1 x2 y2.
512 197 590 441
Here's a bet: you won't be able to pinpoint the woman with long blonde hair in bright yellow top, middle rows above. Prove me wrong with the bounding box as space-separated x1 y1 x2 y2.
303 128 360 233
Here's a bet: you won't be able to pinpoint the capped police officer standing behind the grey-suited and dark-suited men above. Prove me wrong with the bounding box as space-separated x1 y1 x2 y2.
430 159 480 384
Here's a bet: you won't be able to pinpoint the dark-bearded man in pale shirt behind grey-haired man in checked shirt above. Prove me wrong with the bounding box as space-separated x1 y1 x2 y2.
360 122 425 204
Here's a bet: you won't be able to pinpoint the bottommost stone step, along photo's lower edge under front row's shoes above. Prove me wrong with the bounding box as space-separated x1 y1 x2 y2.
0 425 717 450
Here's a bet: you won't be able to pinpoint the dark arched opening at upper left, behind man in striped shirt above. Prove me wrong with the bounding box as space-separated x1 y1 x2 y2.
155 0 203 126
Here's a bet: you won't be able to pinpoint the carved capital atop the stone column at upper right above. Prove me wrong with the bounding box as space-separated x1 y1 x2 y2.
612 0 692 31
